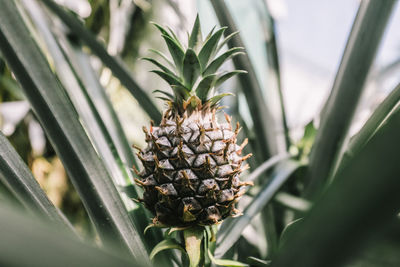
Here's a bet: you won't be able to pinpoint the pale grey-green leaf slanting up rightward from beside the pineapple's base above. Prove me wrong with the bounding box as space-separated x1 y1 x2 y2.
215 160 301 257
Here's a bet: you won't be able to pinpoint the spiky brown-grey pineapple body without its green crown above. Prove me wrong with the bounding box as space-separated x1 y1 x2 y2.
136 109 252 227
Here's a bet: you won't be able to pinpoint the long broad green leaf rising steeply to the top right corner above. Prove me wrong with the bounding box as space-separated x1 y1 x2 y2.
305 1 396 198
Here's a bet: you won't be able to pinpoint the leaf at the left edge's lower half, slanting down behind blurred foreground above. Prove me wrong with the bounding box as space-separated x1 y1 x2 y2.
0 132 73 232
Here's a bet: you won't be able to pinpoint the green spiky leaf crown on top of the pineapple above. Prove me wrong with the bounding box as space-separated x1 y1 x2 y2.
143 15 246 111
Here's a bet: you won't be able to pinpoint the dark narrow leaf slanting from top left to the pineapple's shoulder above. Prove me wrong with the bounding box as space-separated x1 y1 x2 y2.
42 0 161 123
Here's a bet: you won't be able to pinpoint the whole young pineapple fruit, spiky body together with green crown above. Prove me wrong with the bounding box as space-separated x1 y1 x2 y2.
136 17 250 227
